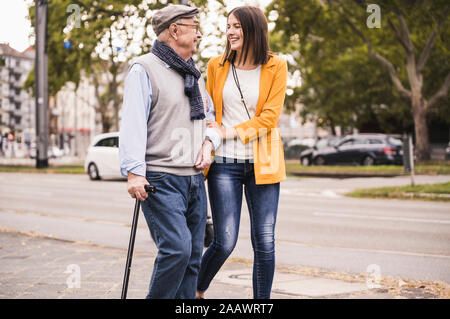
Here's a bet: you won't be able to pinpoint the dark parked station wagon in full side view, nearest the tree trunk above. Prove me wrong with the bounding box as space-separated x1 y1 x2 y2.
312 134 403 166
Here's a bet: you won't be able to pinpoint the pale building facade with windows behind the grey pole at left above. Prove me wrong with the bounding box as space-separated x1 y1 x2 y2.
0 43 101 157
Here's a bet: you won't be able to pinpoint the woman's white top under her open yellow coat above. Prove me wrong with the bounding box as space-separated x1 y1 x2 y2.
215 65 261 159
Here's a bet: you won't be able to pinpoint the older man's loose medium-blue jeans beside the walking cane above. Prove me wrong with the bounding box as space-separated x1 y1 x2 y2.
141 172 207 299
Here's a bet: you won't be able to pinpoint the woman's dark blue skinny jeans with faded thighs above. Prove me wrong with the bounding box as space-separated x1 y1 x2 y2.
197 157 280 299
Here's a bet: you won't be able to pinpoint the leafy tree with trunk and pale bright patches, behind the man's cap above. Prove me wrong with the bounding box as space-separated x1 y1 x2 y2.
26 0 202 132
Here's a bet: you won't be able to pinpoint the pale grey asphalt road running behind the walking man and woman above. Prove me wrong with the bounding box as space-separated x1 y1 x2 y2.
0 173 450 283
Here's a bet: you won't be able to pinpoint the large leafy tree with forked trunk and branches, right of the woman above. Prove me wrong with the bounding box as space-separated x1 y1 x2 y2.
269 0 450 160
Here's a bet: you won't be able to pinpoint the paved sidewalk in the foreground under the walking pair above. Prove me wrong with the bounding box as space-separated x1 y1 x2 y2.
0 231 448 299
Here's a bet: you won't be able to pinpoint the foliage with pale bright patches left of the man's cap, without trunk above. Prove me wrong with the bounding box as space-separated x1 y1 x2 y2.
25 0 212 95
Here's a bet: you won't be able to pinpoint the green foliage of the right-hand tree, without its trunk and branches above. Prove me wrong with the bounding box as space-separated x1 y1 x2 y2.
267 0 450 133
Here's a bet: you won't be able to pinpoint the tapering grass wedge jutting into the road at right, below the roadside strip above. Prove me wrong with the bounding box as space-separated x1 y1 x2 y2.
346 182 450 202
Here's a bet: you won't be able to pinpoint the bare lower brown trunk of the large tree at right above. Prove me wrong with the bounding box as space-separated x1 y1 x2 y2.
411 96 430 162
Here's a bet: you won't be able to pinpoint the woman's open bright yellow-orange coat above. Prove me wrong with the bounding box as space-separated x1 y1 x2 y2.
205 55 287 184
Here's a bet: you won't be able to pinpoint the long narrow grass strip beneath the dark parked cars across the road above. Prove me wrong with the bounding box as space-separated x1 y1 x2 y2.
286 162 450 176
